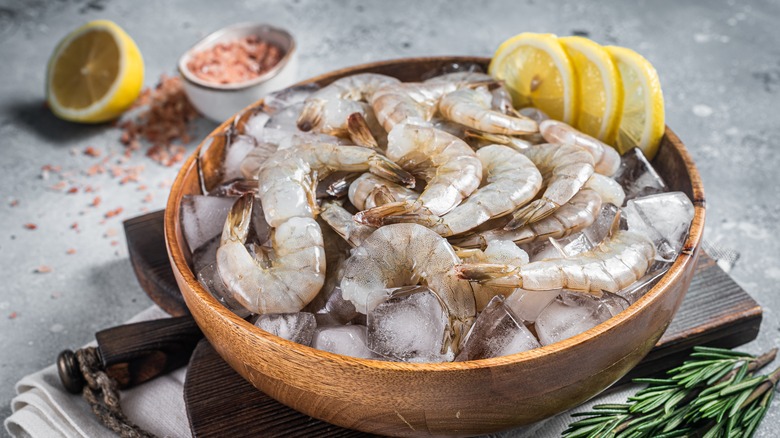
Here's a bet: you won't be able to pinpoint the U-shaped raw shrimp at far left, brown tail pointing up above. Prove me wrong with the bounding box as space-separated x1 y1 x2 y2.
217 193 325 314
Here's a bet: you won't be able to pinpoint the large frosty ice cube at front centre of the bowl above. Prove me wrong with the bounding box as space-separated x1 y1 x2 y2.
367 287 453 362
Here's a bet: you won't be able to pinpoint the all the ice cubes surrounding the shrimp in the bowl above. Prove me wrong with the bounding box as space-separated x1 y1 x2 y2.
182 84 694 362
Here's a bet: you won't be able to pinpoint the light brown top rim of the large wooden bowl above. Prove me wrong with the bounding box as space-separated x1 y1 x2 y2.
165 56 705 372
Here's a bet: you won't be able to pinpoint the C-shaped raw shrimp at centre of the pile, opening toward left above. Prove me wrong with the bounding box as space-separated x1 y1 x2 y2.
356 124 482 222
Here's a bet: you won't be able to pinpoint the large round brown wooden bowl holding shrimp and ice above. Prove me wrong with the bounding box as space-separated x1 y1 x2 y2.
165 57 705 436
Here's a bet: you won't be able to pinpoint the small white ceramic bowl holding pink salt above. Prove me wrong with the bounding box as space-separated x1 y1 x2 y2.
179 23 298 122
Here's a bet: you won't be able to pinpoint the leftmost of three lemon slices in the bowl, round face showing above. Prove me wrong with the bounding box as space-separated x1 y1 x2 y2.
488 33 577 124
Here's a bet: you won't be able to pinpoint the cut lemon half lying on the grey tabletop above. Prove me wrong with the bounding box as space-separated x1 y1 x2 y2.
46 20 144 123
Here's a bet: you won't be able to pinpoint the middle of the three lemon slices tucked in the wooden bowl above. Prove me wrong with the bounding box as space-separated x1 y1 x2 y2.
558 36 623 145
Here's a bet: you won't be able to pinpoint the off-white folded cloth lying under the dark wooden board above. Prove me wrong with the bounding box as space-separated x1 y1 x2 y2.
5 306 639 438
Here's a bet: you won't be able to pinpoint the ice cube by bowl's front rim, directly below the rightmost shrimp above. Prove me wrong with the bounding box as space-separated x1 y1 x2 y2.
535 291 612 345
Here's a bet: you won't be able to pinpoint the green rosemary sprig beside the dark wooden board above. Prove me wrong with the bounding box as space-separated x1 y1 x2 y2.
563 347 780 438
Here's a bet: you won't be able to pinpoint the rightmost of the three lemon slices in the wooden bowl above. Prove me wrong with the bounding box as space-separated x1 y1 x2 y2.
604 46 665 159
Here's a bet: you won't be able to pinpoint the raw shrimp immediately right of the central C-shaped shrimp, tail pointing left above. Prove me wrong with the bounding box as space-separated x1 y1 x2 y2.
362 145 542 237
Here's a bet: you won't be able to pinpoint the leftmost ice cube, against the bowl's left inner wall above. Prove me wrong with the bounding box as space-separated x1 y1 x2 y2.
181 195 236 251
